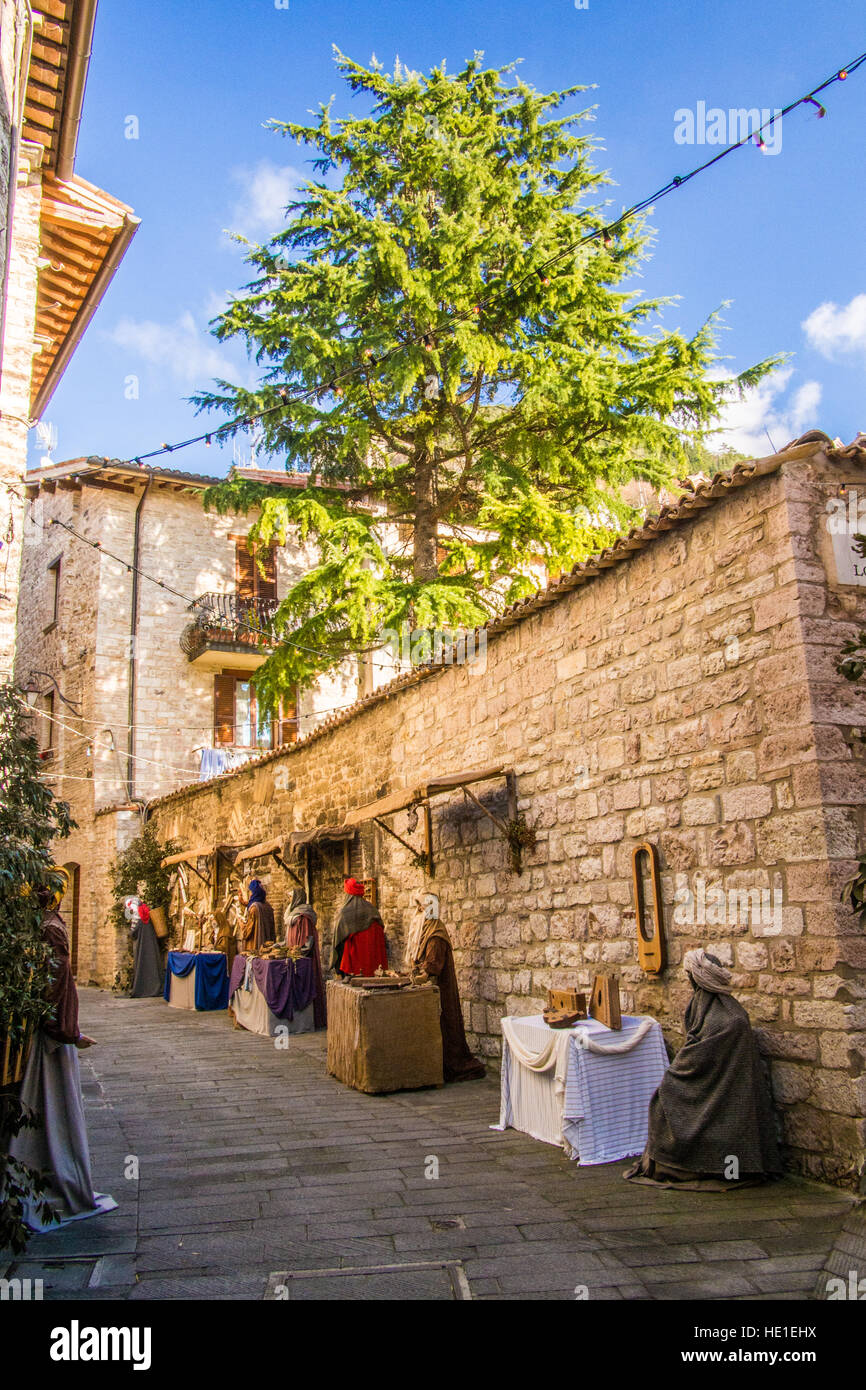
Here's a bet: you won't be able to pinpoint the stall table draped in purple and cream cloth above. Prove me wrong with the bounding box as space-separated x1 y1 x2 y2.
228 955 316 1038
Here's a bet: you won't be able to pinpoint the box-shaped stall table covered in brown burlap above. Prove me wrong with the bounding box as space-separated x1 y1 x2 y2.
328 980 443 1094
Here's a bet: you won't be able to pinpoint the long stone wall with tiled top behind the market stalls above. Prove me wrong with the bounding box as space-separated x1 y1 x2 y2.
122 436 866 1186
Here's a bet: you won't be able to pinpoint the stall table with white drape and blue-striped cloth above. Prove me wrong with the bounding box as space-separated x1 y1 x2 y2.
493 1015 667 1165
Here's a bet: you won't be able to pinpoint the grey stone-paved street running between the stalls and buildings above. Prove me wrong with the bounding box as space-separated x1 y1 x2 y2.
0 990 852 1300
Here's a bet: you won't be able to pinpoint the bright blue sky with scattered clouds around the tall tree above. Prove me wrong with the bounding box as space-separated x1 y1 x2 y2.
37 0 866 474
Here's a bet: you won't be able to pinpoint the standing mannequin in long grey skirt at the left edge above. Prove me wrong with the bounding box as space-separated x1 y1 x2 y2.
8 890 117 1232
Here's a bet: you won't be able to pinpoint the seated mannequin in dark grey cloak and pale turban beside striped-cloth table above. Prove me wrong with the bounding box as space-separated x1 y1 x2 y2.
624 951 781 1187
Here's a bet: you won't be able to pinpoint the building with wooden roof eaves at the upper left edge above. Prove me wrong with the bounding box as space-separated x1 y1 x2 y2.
0 0 138 676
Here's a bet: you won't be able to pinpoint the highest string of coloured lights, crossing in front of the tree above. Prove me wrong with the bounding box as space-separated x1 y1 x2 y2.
97 53 866 467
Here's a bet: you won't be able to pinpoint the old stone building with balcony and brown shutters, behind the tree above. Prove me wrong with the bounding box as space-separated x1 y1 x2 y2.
15 459 392 979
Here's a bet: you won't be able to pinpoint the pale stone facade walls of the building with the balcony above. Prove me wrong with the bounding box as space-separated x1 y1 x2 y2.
15 477 372 984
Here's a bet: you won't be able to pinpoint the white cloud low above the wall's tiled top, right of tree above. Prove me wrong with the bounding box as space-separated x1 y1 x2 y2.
708 367 822 457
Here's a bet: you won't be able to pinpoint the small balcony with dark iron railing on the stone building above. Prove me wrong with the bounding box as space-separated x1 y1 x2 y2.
181 594 279 671
